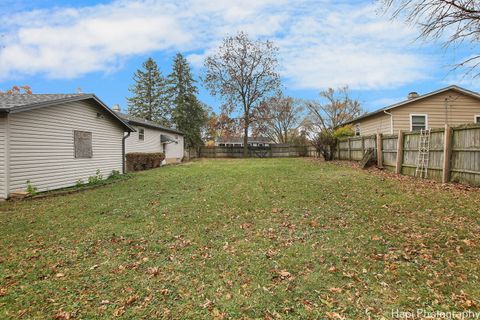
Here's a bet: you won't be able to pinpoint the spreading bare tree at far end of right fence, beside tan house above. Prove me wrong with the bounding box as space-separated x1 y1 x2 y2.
304 87 363 161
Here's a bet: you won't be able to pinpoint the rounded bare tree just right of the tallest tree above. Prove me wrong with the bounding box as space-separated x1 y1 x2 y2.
253 95 305 143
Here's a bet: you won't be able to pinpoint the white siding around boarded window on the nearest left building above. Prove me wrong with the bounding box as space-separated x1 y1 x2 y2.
9 101 124 192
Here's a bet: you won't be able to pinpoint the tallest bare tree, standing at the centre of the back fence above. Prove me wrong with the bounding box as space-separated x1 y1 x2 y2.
203 32 280 156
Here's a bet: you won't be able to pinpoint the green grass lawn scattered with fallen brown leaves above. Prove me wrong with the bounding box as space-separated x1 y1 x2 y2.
0 159 480 319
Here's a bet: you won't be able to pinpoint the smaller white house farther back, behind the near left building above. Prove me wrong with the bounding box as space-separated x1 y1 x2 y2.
113 110 184 164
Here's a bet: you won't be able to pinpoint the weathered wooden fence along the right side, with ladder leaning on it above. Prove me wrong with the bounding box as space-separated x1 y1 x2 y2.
336 125 480 186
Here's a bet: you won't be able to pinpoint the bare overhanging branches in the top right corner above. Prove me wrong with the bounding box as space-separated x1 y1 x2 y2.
379 0 480 77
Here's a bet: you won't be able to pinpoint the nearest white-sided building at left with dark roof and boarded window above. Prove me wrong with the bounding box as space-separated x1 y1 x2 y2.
0 94 134 199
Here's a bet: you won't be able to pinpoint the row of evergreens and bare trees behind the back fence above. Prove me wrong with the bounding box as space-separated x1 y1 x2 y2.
128 32 362 156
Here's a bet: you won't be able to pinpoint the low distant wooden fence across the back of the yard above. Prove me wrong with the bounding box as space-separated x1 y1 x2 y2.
200 144 318 158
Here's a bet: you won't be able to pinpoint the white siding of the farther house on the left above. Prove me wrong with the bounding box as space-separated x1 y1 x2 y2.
125 126 184 163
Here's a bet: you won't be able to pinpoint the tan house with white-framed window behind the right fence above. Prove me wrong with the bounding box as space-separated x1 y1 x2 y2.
345 86 480 135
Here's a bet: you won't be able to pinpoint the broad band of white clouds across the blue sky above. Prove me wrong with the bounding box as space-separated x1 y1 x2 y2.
0 0 430 89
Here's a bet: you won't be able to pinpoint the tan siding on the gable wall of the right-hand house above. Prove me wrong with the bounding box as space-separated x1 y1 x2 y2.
391 90 480 132
